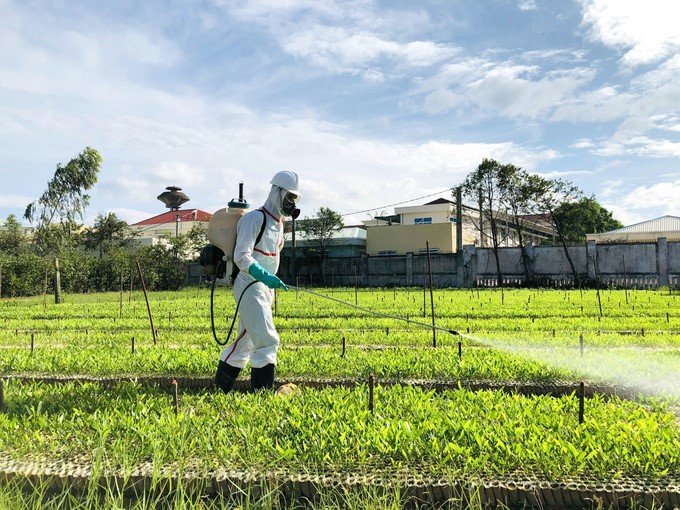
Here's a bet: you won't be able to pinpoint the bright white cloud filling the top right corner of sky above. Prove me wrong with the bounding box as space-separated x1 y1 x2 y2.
580 0 680 66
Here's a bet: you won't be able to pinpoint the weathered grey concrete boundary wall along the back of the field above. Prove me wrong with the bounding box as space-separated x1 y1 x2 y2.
189 237 680 289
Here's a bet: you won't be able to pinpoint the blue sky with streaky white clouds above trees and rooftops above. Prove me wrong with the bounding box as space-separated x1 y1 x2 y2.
0 0 680 225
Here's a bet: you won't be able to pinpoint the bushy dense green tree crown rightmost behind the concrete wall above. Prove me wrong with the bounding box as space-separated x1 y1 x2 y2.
555 196 623 244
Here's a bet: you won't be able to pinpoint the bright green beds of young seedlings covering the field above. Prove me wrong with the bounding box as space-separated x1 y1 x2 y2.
0 286 680 508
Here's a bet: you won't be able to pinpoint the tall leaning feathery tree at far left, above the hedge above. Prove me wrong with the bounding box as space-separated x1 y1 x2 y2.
24 147 102 251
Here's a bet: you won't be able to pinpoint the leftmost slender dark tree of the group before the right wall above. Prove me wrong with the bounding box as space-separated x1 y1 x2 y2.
461 158 514 287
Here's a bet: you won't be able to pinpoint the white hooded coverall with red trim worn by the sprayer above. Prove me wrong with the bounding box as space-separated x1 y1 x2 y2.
220 186 285 368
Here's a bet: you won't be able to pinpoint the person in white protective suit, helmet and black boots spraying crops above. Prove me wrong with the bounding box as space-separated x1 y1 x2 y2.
215 171 300 393
